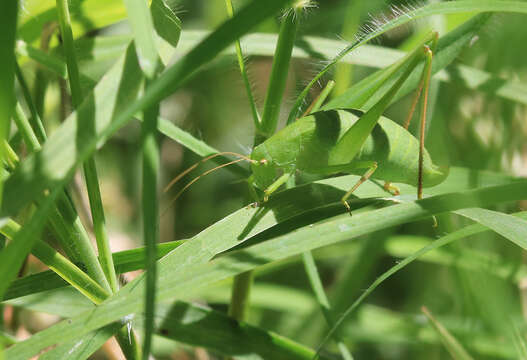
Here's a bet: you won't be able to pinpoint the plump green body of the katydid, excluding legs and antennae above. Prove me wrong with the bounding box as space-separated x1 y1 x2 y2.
251 110 447 190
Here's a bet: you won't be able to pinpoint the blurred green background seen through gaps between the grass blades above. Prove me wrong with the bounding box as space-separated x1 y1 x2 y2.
13 0 527 359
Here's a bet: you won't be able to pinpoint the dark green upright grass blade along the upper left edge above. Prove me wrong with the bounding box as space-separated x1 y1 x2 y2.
0 0 18 204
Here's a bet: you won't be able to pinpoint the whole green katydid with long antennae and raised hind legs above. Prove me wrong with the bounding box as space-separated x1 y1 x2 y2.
166 34 447 214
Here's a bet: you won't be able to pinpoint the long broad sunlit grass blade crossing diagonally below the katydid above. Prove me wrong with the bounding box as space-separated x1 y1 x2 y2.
6 180 527 359
